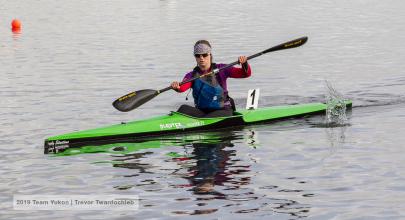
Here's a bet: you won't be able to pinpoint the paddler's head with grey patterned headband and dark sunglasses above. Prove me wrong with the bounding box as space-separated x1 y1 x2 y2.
194 40 212 70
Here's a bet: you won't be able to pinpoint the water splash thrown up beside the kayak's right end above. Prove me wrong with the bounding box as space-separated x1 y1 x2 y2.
325 80 348 126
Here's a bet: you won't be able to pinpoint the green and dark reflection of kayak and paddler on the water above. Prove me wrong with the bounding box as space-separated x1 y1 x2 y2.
54 130 249 194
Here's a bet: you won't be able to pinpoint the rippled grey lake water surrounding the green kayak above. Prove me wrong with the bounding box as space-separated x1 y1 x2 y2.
0 0 405 219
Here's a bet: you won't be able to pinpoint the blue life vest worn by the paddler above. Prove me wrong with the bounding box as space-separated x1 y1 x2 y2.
192 64 225 110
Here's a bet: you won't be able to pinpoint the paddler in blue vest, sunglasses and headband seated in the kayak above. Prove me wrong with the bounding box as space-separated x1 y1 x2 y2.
171 40 252 118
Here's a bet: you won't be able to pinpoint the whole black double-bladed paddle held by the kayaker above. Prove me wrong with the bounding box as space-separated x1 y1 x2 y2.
113 37 308 112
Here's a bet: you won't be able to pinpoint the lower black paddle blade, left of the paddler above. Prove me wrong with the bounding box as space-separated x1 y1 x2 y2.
113 89 159 112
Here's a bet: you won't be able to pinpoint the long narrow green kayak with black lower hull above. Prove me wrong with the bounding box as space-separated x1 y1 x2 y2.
44 101 352 154
